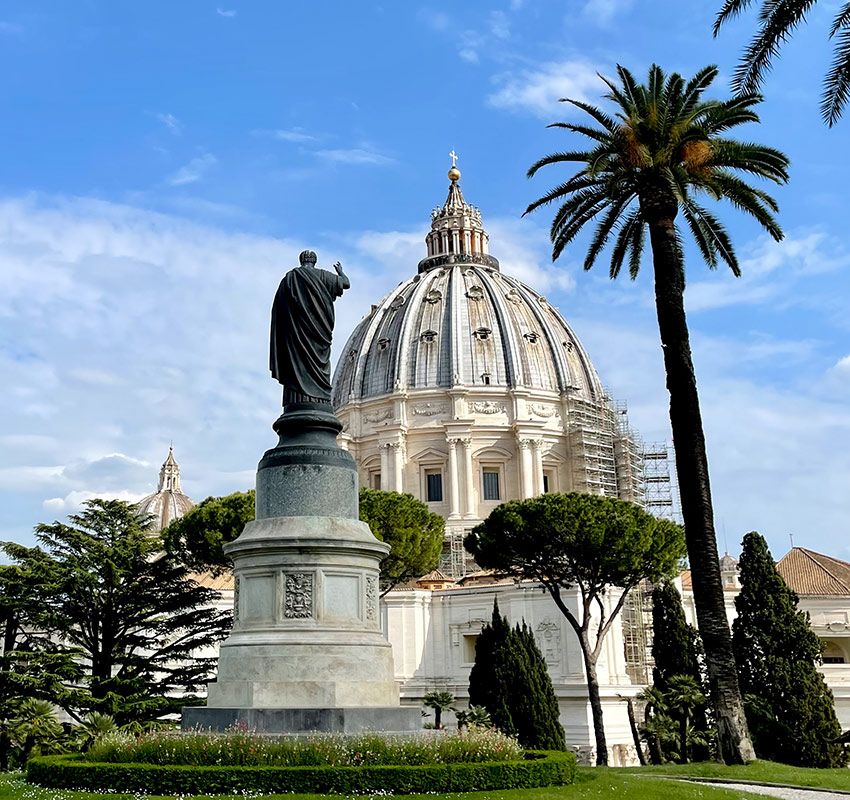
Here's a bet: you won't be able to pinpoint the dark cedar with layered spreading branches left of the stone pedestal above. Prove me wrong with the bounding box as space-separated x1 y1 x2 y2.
3 500 230 724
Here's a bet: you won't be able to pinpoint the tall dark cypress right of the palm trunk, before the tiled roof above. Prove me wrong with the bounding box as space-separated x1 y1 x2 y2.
732 532 847 767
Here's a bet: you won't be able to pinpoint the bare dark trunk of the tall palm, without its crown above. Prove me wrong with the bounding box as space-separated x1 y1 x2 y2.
649 214 755 764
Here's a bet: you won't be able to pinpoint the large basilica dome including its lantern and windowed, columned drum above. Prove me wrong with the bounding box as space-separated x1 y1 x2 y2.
332 159 646 578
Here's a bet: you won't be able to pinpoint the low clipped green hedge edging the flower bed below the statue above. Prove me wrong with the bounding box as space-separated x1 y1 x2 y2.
27 750 576 795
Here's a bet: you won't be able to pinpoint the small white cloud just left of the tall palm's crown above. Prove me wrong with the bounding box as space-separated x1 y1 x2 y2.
487 59 602 120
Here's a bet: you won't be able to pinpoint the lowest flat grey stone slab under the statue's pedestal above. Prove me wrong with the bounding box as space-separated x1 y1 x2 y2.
182 706 422 734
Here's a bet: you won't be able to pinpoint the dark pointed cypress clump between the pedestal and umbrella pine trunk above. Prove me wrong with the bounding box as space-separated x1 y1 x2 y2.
469 600 566 750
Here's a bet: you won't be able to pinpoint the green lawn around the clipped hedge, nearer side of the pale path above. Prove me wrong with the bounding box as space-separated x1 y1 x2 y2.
0 767 755 800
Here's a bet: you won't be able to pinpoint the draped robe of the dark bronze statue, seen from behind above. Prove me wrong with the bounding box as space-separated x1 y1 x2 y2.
269 267 343 405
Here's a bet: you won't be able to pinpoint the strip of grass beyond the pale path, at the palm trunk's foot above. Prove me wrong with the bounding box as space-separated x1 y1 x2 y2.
626 761 850 792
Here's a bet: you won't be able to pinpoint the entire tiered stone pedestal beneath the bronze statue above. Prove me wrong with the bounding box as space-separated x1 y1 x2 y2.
188 404 421 733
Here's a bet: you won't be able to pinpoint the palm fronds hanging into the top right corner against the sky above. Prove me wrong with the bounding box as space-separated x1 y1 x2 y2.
714 0 850 128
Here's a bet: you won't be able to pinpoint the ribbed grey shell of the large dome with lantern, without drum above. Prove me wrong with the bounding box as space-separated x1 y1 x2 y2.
333 173 603 408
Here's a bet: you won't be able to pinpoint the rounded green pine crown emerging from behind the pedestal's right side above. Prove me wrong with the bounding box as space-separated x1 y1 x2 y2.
360 489 446 595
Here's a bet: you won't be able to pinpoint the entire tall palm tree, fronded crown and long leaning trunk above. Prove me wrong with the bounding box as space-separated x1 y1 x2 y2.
525 65 788 763
